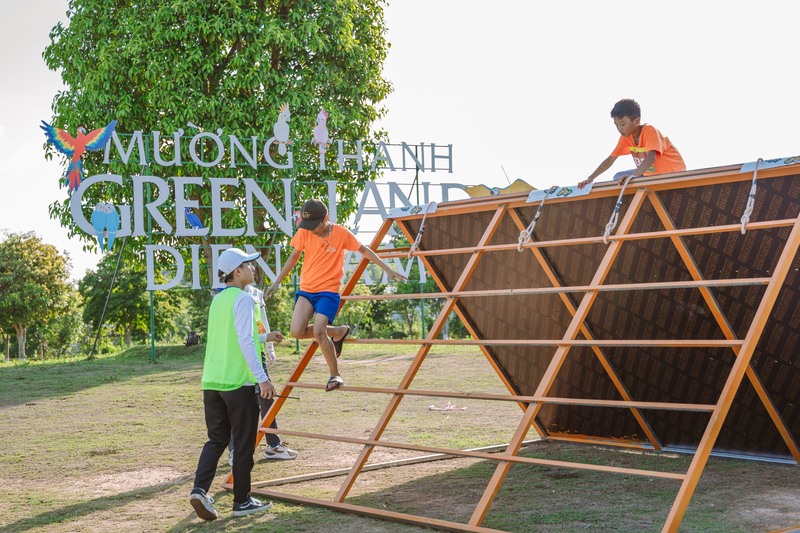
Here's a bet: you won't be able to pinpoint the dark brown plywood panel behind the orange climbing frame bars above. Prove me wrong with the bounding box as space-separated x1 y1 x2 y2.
399 169 800 457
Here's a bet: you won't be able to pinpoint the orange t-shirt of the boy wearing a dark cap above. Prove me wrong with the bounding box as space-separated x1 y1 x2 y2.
291 224 361 292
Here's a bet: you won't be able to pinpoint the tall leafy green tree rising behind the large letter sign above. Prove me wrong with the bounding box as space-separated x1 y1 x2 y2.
43 0 391 284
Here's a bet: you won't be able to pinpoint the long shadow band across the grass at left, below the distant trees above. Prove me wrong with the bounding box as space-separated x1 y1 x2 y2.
0 344 205 407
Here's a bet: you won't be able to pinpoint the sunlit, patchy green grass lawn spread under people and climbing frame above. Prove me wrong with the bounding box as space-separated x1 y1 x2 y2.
0 343 800 532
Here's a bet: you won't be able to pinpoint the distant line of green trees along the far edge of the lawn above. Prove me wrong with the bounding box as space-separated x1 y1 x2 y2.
0 233 467 361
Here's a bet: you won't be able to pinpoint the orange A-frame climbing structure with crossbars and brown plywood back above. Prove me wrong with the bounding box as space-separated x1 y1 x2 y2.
229 161 800 531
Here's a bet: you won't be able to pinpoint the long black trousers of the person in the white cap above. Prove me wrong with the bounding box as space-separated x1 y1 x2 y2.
194 385 258 503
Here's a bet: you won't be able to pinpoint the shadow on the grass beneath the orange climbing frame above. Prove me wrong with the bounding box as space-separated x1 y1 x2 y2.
244 443 748 532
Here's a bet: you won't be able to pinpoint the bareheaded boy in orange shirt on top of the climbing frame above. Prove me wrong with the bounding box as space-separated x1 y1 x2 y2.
578 99 686 189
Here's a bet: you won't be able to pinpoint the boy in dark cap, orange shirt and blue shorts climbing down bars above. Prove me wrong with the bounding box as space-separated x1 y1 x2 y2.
264 199 406 391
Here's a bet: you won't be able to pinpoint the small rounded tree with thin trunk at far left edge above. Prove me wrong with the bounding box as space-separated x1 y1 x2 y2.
0 233 71 360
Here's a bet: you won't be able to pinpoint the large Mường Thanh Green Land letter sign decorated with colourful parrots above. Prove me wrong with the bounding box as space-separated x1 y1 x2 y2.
42 109 464 290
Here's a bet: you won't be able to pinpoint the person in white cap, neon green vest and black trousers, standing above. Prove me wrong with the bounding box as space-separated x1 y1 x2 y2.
189 248 279 520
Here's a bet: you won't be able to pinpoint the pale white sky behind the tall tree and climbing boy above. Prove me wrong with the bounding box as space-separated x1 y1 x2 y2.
0 0 800 279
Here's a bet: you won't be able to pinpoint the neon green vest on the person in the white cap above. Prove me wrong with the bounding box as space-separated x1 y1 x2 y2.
200 287 259 391
